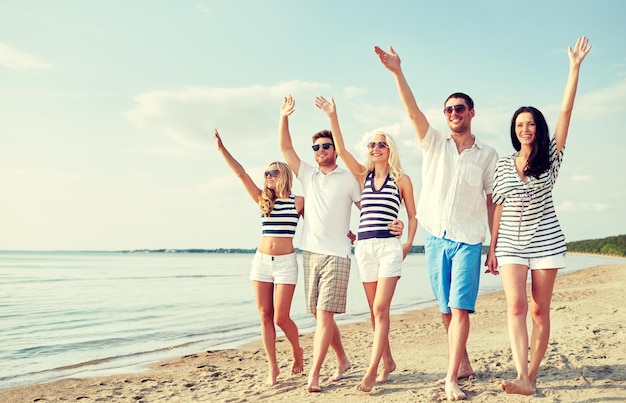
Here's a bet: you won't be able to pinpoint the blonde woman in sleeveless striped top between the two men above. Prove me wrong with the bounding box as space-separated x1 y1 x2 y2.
315 97 417 392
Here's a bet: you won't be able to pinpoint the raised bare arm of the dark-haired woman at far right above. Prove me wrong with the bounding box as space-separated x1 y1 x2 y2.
555 36 591 153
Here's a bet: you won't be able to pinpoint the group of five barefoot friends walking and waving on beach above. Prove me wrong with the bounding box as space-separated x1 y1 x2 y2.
214 37 591 400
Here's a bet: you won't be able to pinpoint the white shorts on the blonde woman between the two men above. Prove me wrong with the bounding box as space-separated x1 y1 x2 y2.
354 238 403 283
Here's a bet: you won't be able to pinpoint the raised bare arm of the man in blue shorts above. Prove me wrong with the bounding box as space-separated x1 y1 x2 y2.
374 46 429 141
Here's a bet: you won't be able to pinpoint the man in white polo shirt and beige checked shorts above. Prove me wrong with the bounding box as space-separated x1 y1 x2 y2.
279 96 361 392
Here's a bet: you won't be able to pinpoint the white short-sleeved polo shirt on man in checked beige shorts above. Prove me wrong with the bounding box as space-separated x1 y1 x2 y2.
297 161 361 257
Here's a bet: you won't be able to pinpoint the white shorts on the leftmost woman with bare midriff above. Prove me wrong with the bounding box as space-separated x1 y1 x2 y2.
250 251 298 284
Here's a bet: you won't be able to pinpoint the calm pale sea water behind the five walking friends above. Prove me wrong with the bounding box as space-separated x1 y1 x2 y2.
0 251 623 389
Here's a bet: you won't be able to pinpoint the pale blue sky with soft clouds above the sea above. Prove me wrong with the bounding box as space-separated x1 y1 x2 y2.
0 0 626 250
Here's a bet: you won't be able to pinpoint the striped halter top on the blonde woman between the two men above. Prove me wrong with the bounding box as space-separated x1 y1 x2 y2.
359 172 400 240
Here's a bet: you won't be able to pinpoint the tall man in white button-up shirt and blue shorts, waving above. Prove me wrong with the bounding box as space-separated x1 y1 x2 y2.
374 46 498 400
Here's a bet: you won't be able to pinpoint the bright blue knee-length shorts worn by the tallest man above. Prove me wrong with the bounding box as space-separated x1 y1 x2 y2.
424 232 482 313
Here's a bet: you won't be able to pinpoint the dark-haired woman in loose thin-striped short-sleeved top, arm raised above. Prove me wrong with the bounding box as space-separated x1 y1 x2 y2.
486 37 591 395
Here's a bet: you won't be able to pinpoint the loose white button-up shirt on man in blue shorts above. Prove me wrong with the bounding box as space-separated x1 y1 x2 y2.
417 126 498 244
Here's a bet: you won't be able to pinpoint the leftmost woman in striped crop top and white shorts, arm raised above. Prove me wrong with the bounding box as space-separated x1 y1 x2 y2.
213 129 304 386
